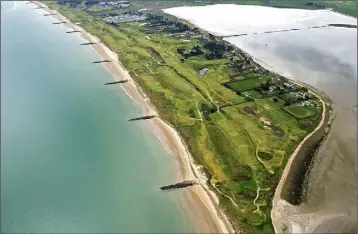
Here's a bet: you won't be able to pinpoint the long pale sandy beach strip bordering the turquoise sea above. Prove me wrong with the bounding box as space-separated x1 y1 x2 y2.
32 1 235 233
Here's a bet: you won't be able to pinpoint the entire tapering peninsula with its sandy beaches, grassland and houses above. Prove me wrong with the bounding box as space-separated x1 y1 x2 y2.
36 1 331 233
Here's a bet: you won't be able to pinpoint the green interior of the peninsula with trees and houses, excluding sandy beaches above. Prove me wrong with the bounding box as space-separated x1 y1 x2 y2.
46 2 322 233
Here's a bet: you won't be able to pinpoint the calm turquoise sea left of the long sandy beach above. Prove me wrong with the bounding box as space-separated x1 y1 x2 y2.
1 2 191 233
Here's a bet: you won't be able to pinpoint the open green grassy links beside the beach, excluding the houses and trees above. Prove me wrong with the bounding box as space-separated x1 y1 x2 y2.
46 2 324 233
